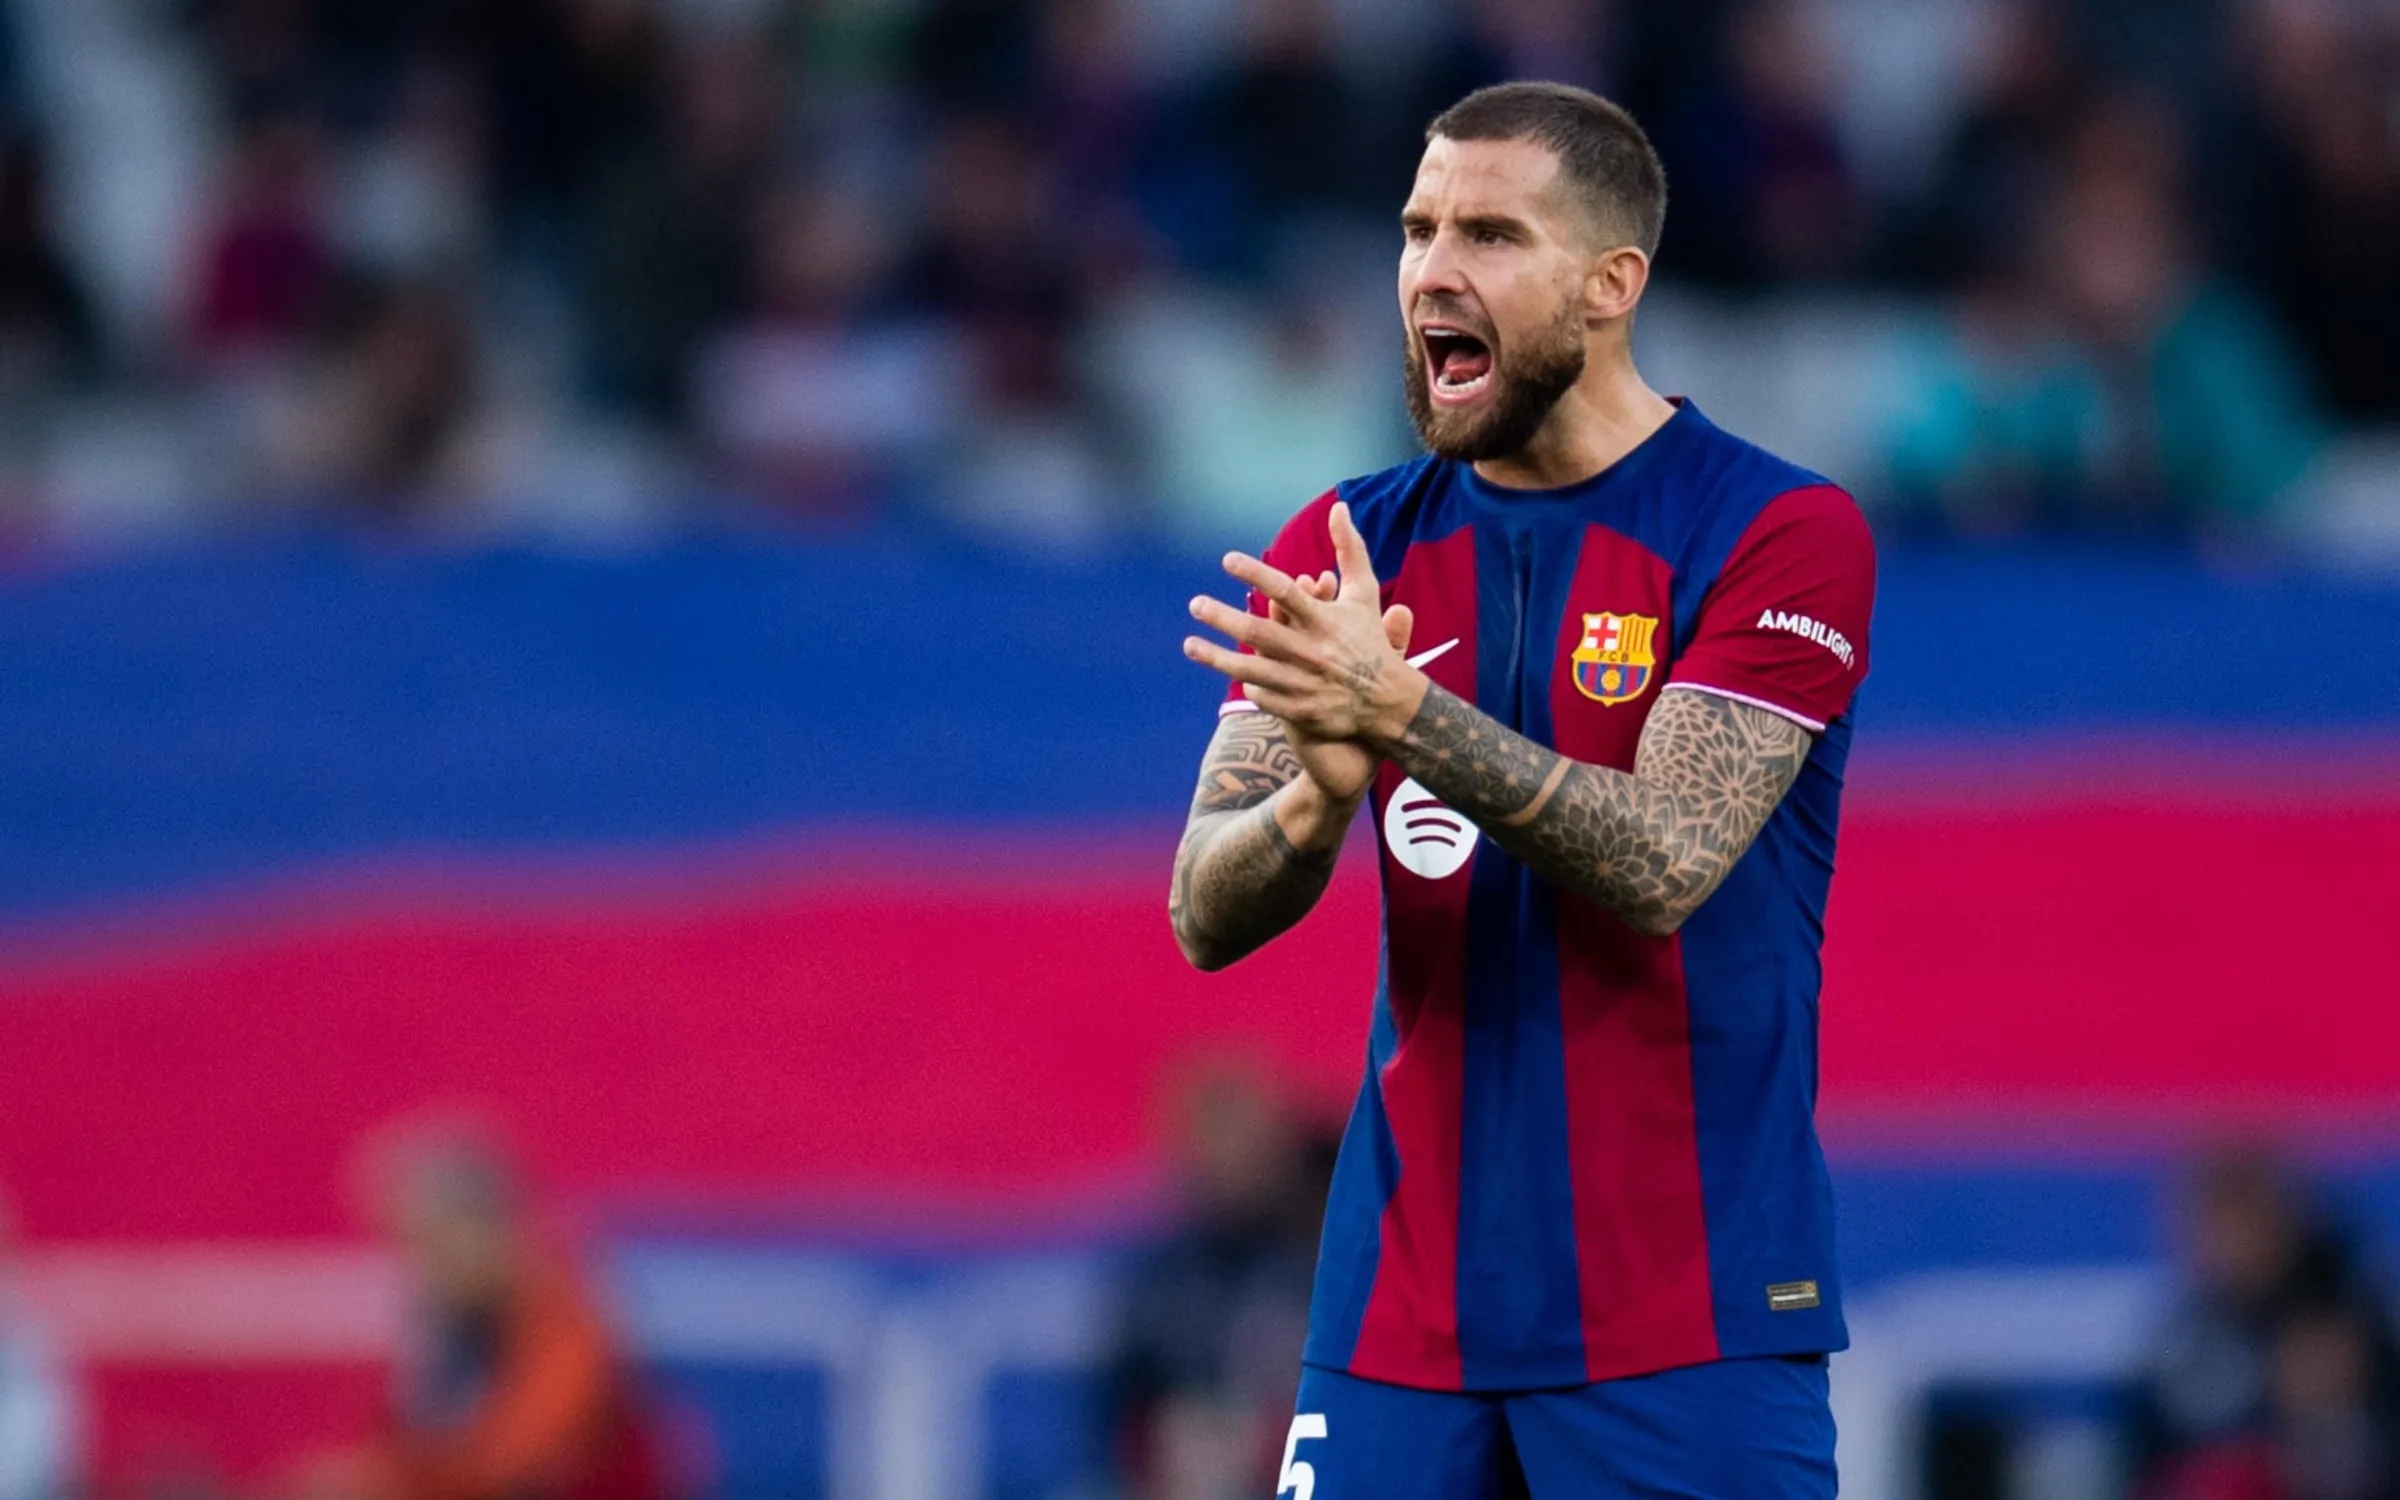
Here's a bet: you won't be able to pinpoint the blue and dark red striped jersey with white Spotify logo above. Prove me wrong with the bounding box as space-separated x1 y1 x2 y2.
1229 406 1874 1390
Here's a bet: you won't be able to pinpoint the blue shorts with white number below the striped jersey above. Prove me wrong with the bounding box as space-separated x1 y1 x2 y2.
1277 1356 1836 1500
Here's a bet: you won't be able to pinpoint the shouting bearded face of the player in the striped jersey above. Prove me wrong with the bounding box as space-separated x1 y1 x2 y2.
1399 139 1591 463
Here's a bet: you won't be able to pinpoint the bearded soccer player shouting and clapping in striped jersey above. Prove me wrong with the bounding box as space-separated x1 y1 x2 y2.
1171 84 1874 1500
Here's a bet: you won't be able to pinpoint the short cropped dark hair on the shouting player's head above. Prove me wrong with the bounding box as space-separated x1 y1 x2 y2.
1426 84 1666 257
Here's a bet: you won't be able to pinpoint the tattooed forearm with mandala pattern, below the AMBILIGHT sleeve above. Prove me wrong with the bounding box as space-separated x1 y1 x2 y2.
1392 686 1810 936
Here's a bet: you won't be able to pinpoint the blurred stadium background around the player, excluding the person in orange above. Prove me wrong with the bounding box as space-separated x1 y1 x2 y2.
0 0 2400 1500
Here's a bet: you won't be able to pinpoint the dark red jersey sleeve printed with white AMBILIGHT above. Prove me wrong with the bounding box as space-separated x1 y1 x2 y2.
1666 485 1874 734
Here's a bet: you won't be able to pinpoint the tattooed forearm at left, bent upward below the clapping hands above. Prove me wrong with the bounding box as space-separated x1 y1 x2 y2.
1166 713 1337 970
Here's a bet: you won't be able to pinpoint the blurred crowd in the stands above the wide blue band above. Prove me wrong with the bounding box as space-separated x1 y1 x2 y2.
0 0 2400 545
